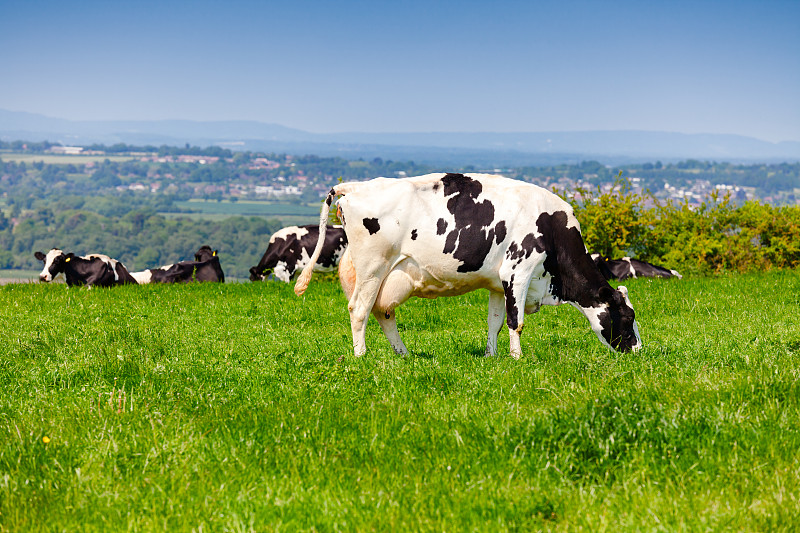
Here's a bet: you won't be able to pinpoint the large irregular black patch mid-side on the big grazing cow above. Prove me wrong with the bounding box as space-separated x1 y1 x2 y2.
442 174 505 272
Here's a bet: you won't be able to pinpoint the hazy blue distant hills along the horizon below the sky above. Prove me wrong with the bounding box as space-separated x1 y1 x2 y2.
0 109 800 166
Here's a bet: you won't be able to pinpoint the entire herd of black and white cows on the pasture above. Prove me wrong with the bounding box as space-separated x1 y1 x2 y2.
35 174 681 357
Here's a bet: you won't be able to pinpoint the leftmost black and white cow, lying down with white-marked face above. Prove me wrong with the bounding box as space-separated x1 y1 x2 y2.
33 248 136 287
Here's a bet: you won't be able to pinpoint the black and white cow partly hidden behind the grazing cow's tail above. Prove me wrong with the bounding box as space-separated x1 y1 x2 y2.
250 225 347 283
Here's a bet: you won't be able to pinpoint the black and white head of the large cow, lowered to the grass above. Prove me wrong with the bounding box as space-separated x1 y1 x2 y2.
590 285 642 352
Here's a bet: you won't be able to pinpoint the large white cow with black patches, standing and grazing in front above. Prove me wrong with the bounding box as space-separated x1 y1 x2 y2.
295 174 642 358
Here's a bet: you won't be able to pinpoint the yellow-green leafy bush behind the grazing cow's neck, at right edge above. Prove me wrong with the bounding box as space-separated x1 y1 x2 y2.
570 178 800 275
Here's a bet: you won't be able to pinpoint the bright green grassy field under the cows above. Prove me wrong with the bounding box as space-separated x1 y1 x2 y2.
0 272 800 531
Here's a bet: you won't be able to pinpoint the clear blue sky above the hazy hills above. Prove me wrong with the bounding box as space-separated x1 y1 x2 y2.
0 0 800 141
